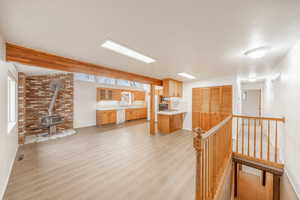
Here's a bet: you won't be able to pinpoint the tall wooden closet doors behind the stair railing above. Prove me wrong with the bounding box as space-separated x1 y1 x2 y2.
192 85 232 131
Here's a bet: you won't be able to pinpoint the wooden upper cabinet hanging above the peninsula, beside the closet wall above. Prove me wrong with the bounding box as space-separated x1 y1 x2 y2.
163 79 182 97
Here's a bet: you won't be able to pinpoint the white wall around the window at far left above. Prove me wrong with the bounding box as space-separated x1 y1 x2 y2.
0 32 18 199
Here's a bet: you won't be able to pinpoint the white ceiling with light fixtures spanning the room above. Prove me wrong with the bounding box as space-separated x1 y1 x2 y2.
0 0 300 80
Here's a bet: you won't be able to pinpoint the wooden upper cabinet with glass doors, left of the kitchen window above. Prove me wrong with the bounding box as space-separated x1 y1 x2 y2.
97 88 121 101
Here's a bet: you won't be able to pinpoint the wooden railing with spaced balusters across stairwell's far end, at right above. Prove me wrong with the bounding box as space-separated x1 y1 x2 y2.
233 115 285 163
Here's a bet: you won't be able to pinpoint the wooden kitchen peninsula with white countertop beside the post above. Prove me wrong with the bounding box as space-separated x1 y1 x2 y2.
157 110 185 134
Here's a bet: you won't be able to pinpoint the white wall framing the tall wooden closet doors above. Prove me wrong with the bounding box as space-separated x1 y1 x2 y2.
183 76 239 130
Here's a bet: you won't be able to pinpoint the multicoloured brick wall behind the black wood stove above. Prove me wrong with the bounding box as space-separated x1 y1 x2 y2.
19 74 73 140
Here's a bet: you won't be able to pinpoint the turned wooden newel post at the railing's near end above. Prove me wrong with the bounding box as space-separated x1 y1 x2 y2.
194 128 203 200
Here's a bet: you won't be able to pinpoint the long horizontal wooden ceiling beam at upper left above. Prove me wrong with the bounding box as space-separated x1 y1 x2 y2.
6 43 162 85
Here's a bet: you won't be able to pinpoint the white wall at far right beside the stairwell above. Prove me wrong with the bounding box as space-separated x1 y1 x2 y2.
264 41 300 197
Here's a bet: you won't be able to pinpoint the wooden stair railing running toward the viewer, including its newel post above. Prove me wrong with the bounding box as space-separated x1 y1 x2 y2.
194 115 232 200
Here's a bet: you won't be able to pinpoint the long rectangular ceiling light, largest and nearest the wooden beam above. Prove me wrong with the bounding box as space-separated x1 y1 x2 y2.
101 40 156 63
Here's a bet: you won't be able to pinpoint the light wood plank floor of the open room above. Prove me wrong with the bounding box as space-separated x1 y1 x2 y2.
4 121 195 200
